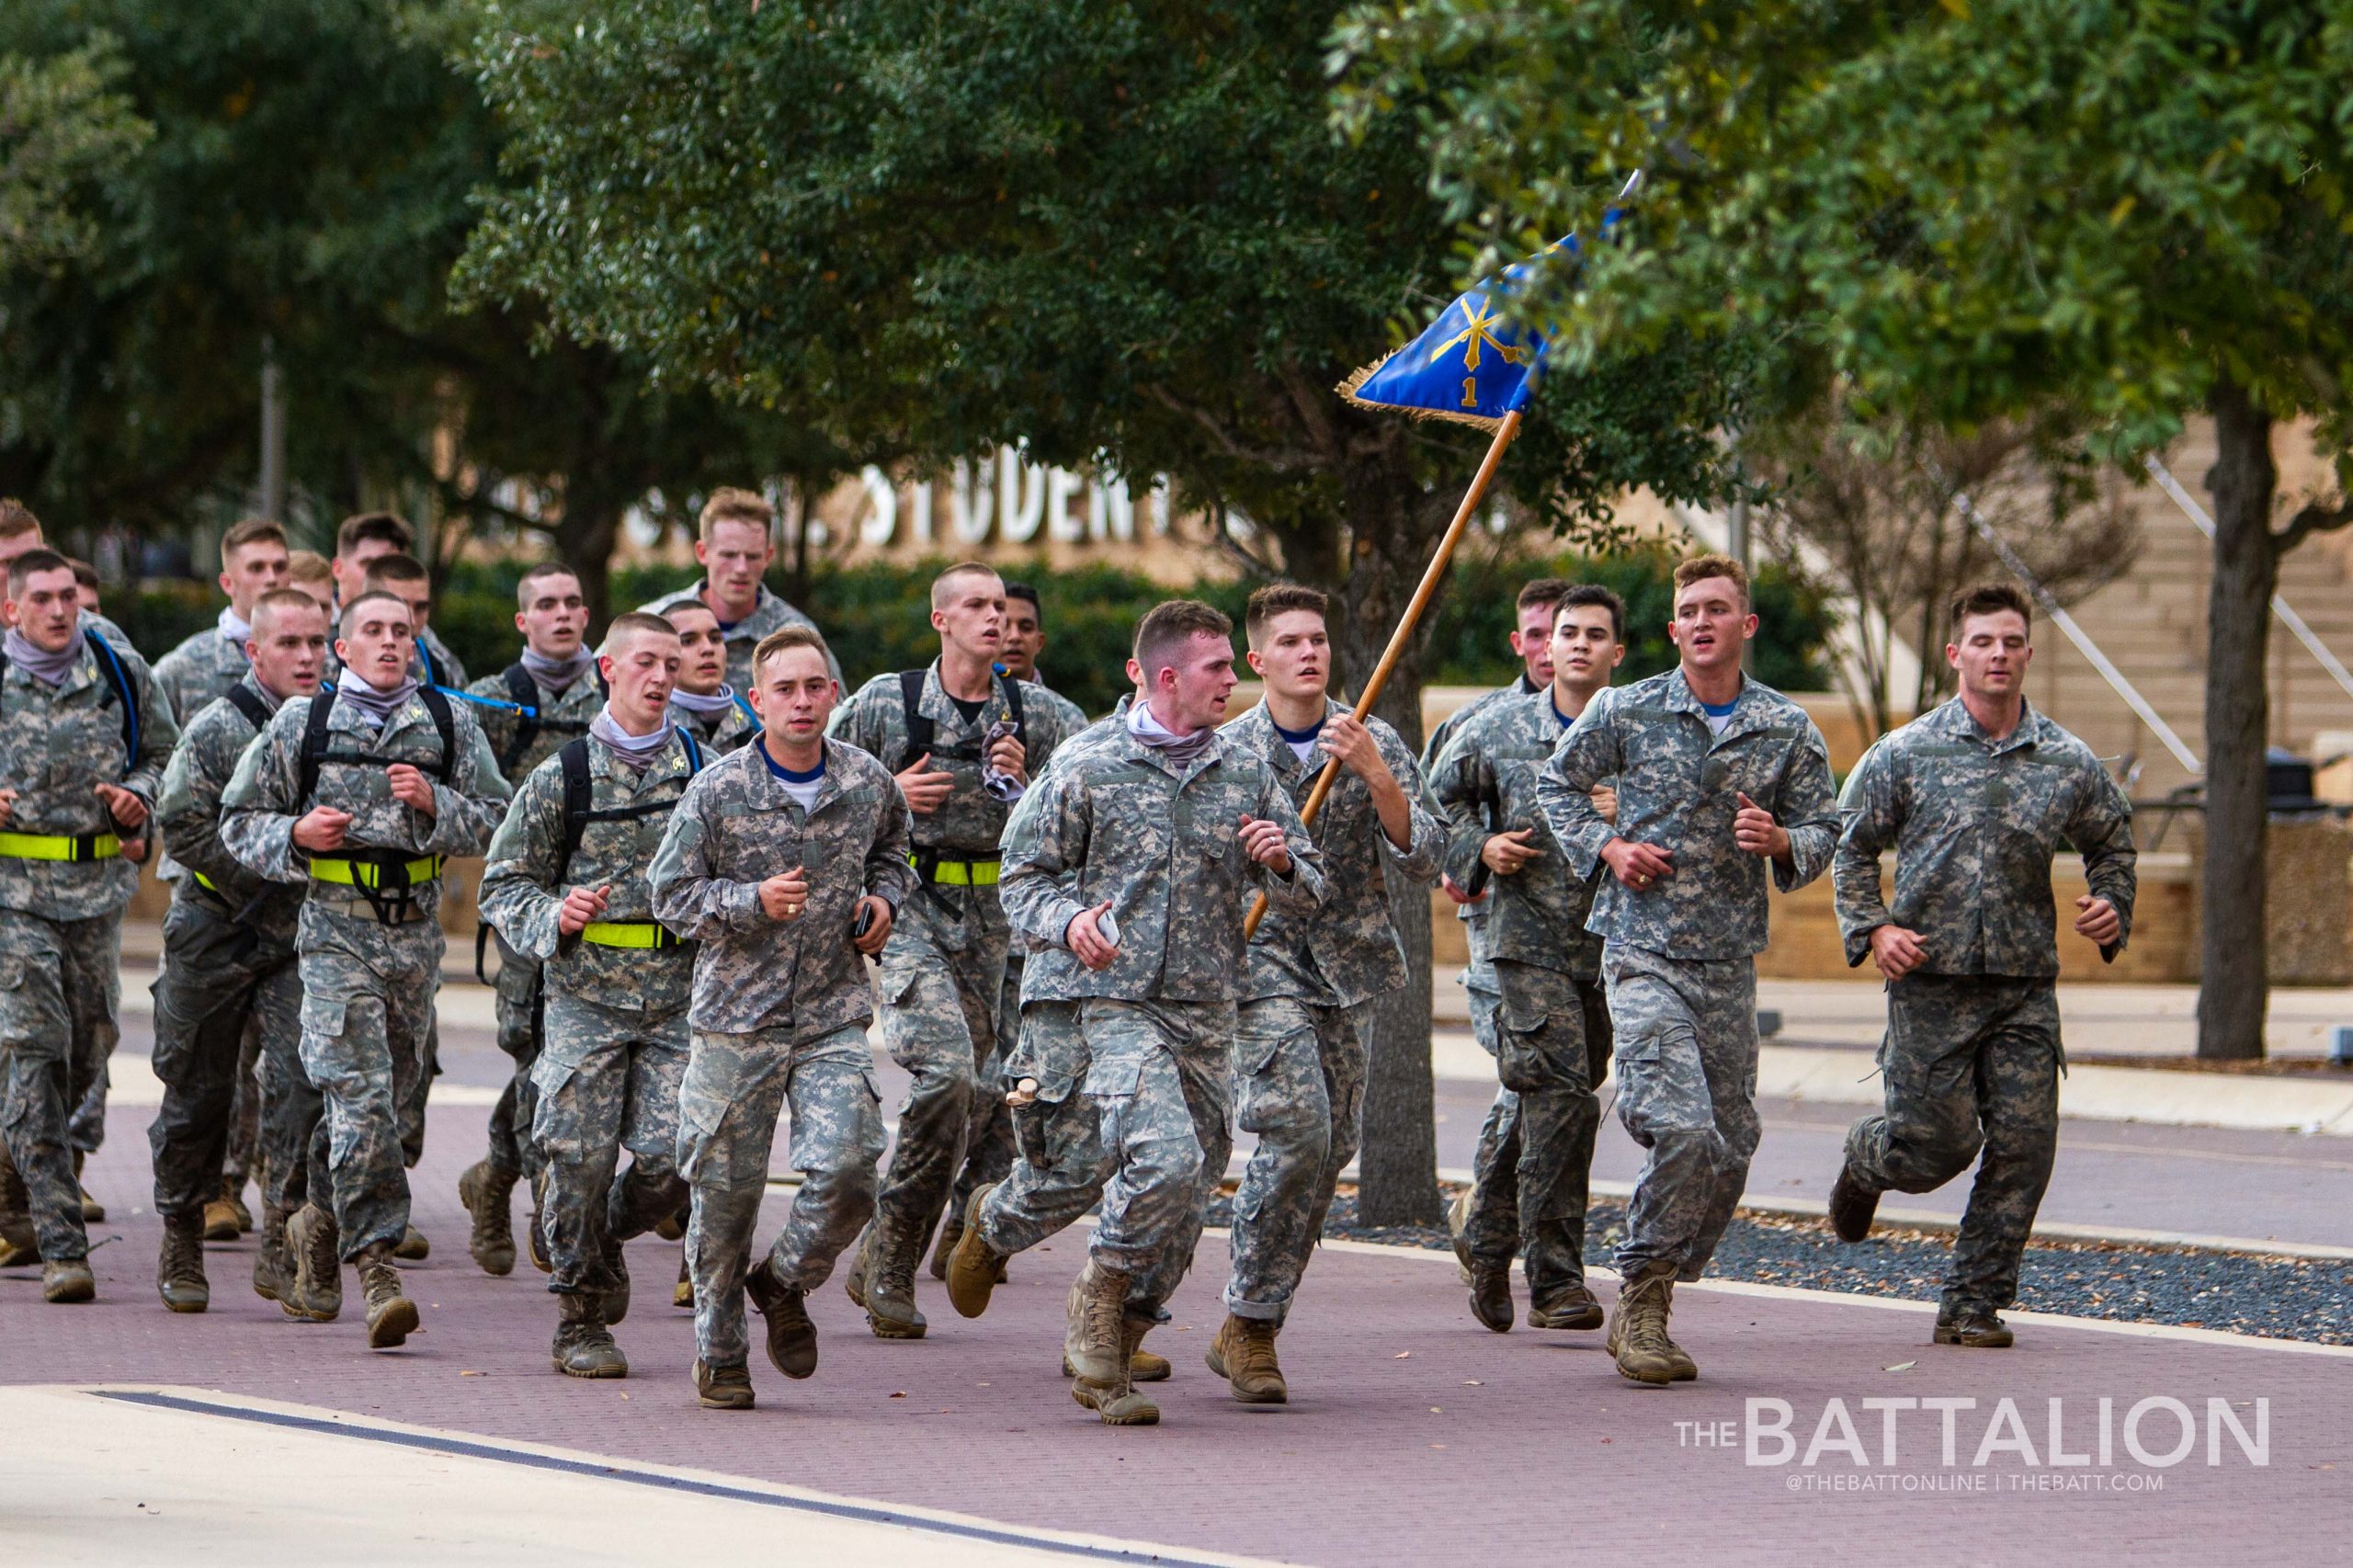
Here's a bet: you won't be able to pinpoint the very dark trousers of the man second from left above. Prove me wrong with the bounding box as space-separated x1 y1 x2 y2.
148 900 308 1220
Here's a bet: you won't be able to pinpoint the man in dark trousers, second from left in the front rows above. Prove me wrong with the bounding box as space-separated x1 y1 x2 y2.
148 588 327 1312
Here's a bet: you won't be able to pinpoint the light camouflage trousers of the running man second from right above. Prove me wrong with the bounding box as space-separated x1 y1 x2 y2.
1602 942 1760 1280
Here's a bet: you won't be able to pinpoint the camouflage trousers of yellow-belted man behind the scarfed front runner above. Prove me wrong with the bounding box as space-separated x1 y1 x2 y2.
875 890 1005 1245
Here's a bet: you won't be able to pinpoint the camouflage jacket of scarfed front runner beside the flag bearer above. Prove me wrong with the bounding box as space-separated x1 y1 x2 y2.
997 697 1323 1003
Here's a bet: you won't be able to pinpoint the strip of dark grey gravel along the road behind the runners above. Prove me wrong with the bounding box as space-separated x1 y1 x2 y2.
1210 1191 2353 1345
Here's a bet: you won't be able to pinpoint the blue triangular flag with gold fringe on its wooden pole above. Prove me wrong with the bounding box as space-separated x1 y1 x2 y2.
1243 201 1640 939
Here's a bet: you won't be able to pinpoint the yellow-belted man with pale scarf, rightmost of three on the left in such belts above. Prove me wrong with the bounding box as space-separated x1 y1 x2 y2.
483 615 706 1378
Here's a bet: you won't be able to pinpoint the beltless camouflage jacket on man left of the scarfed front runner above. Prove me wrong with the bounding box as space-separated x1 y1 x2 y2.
650 739 915 1040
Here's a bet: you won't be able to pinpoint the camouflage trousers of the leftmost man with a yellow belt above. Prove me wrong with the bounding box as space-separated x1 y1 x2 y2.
0 909 122 1259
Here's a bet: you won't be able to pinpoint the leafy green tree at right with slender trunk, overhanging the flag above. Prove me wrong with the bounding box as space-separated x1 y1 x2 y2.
1336 0 2353 1055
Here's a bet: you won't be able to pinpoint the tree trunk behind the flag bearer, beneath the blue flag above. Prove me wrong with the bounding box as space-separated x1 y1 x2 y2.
1336 451 1454 1224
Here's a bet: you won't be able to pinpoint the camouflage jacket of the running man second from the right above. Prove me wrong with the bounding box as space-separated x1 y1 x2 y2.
1537 668 1837 959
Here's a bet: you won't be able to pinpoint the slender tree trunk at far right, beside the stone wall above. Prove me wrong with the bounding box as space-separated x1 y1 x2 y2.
2198 379 2280 1062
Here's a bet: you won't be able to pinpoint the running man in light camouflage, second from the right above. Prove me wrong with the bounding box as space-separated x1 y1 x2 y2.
1539 556 1837 1382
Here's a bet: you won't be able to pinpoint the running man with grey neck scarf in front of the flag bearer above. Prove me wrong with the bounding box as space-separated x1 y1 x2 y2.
949 600 1323 1425
